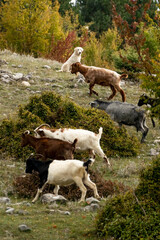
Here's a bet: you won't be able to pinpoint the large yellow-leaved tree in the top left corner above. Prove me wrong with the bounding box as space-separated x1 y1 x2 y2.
0 0 63 56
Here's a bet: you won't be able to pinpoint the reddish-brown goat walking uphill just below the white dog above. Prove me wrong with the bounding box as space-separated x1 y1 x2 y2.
71 62 128 102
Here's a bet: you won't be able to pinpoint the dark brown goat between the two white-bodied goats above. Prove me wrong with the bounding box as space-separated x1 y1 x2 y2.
21 131 77 161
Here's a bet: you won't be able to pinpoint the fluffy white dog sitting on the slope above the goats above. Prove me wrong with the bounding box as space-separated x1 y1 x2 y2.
58 47 83 72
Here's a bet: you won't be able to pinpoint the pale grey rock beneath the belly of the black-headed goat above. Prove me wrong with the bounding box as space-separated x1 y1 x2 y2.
41 193 67 203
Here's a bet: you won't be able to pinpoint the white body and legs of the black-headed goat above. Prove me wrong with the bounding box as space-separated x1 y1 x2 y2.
32 159 99 202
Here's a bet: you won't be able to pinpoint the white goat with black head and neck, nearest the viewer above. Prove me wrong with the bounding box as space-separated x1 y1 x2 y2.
26 157 100 203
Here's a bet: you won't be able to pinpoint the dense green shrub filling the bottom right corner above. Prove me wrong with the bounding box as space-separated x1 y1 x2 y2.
96 156 160 240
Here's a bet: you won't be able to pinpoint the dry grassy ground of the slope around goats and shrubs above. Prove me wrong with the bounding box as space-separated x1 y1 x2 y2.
0 51 159 240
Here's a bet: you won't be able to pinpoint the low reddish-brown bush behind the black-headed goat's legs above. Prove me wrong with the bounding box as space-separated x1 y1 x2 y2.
13 171 127 201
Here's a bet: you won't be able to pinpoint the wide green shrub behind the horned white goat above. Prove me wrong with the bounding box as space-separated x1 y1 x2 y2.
0 92 139 159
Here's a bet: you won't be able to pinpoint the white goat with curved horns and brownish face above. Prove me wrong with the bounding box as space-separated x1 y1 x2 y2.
34 124 110 166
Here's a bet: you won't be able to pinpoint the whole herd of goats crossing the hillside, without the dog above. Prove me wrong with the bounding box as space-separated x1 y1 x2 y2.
21 56 158 202
